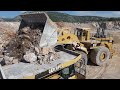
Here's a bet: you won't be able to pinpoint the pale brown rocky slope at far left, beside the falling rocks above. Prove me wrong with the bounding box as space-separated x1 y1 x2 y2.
0 22 19 50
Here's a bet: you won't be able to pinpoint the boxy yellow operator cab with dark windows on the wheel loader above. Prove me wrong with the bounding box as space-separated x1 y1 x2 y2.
75 28 90 41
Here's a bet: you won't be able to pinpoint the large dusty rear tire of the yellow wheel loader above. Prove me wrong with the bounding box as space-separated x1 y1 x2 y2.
90 46 110 66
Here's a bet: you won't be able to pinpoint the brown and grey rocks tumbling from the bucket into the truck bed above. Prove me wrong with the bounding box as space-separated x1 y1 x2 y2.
0 27 59 65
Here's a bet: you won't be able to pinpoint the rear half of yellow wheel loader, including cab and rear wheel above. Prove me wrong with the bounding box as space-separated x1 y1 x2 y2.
74 28 115 66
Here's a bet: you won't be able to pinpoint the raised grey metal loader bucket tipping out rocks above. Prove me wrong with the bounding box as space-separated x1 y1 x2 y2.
19 12 57 47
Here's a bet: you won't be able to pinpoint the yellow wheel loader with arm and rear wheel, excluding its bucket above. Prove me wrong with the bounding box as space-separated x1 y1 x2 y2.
58 28 115 66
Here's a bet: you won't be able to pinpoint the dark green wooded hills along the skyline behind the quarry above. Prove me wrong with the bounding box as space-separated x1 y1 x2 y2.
1 12 120 23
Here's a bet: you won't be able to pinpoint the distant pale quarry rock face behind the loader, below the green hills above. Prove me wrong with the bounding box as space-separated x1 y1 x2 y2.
57 21 120 30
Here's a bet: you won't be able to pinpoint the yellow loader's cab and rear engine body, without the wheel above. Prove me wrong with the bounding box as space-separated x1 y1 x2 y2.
74 28 115 56
